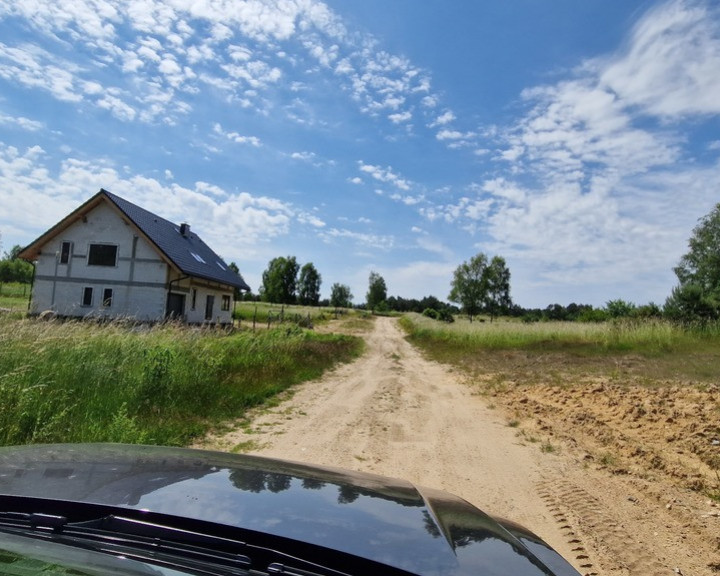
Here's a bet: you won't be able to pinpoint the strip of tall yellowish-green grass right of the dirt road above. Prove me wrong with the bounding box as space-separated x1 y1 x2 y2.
401 314 720 380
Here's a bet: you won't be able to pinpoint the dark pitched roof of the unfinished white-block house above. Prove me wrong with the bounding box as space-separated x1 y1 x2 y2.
21 189 250 292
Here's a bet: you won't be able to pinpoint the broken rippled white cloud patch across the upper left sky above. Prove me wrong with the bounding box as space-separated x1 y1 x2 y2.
0 0 447 132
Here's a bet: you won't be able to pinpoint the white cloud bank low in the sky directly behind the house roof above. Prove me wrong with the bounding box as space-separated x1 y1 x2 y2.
0 143 308 254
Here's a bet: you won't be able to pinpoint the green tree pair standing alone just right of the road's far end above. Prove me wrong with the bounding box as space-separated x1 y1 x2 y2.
448 252 512 322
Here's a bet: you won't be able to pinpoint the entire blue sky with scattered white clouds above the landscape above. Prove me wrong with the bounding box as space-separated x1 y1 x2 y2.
0 0 720 307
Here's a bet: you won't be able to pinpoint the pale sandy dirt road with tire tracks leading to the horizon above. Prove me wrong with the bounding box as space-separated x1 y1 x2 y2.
198 318 720 576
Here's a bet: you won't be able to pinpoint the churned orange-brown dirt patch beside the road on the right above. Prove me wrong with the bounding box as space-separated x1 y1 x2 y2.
501 382 720 497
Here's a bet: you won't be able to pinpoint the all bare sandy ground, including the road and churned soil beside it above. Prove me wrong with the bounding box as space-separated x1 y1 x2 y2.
198 318 720 576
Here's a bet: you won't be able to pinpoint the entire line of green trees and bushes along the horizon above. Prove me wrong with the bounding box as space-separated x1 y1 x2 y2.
0 203 720 323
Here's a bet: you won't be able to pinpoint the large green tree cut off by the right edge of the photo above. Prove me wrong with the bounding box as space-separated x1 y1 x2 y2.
664 204 720 322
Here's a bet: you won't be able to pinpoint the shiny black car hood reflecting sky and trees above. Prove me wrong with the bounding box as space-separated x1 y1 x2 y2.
0 444 577 576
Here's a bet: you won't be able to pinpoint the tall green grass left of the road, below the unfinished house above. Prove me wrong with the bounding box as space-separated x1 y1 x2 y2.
0 318 361 445
